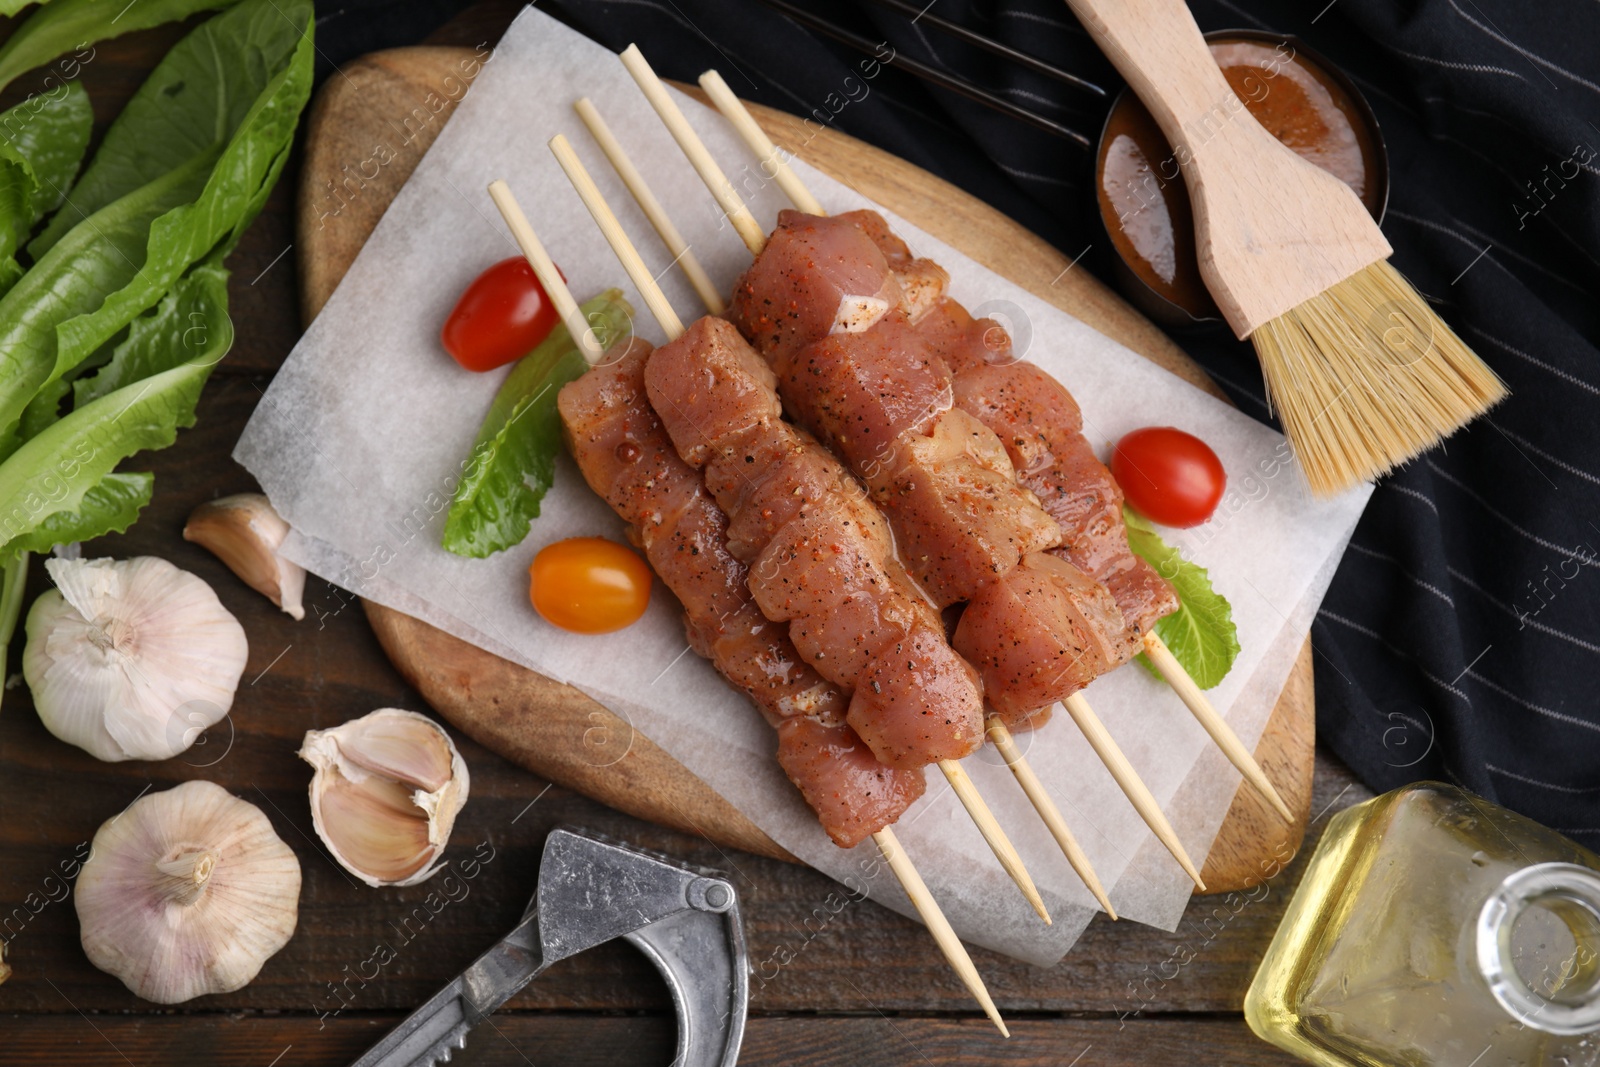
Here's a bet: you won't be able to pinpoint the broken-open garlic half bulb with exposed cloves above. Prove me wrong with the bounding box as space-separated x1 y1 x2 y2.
299 707 470 886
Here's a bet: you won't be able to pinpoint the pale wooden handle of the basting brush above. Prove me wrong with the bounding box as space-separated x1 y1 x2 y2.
1067 0 1390 338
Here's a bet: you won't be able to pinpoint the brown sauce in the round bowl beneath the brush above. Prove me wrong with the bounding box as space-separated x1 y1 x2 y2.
1094 30 1389 325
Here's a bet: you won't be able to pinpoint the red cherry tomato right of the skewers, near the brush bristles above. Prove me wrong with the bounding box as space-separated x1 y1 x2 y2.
1110 426 1227 526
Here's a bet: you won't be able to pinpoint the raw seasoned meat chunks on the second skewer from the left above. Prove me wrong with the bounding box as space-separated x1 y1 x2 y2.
645 318 982 766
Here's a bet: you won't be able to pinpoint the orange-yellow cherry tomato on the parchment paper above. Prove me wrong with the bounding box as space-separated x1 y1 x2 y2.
528 537 650 633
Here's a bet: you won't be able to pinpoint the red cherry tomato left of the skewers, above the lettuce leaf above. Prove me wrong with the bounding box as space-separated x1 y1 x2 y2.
438 256 566 371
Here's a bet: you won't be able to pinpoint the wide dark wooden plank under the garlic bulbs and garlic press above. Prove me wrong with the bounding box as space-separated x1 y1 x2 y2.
0 598 1366 1014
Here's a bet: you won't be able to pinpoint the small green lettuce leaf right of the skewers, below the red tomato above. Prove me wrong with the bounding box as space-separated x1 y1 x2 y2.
1122 506 1238 689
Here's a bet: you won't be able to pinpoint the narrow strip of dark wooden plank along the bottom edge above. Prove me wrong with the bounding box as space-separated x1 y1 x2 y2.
0 1011 1298 1067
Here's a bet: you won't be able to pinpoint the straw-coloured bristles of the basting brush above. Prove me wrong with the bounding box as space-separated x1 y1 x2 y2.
1250 261 1506 496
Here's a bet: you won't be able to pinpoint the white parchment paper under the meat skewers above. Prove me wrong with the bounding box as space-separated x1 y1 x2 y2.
235 8 1368 965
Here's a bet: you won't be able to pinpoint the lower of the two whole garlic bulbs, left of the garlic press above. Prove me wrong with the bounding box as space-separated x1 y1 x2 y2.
75 782 301 1005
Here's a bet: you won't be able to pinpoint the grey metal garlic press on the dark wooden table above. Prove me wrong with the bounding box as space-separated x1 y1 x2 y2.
354 830 750 1067
